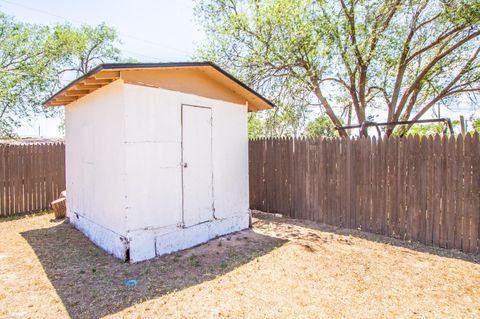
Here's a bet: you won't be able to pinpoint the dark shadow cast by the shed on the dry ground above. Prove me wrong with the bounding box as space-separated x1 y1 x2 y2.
21 222 286 318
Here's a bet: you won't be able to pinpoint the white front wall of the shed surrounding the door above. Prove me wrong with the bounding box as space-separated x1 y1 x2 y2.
124 84 249 261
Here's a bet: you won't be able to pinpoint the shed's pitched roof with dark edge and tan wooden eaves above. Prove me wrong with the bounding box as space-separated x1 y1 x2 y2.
44 62 275 111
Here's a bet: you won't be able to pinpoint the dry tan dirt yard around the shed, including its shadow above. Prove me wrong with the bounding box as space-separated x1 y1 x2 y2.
0 213 480 318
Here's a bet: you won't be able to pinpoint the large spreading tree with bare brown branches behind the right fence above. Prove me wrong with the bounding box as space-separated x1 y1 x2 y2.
196 0 480 136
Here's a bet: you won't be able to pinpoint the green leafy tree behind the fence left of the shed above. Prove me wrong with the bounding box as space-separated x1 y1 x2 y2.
0 12 118 136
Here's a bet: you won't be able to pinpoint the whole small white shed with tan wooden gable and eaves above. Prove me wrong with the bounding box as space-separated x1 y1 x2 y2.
45 62 273 262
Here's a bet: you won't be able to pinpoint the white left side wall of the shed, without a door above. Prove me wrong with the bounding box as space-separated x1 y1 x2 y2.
65 80 127 257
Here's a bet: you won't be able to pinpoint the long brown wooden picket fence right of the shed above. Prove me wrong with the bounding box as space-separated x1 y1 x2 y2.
249 134 480 252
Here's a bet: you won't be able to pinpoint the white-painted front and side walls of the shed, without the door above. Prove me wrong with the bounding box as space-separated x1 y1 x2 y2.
65 80 249 261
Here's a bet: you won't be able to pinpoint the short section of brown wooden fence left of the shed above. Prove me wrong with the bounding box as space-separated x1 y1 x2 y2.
0 143 65 216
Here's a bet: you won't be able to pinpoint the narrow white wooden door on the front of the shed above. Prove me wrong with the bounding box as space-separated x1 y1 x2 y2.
181 105 214 227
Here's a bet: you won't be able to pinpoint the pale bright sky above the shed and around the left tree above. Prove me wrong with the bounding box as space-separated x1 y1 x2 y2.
0 0 203 137
